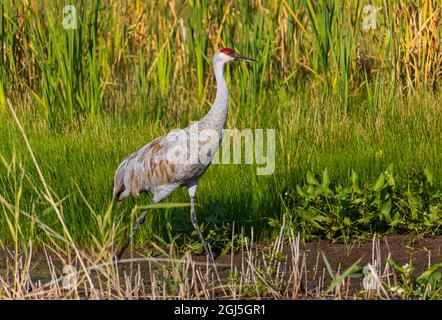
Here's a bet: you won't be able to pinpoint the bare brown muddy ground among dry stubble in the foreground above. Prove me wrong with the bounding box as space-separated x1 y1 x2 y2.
0 236 442 298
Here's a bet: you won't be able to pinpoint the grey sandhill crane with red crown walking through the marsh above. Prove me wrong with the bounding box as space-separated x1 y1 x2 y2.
113 48 256 262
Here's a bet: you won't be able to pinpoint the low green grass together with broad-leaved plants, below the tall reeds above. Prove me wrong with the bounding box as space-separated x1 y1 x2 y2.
0 89 442 250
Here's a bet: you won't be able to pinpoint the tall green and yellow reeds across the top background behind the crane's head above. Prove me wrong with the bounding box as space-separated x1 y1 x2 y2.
0 0 442 126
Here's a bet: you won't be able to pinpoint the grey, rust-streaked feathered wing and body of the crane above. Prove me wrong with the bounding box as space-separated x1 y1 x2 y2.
114 124 219 201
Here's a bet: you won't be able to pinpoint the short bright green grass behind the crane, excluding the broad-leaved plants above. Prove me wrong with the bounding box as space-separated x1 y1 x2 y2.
0 90 442 245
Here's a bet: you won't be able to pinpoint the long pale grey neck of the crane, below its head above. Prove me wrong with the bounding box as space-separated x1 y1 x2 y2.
202 62 228 130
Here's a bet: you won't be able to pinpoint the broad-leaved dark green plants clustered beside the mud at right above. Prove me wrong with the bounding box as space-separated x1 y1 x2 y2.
286 165 442 239
